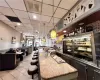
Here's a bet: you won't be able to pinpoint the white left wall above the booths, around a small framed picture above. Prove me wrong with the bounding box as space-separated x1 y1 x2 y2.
0 21 20 50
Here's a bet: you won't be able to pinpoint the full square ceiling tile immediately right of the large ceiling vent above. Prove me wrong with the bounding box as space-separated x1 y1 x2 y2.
42 4 53 16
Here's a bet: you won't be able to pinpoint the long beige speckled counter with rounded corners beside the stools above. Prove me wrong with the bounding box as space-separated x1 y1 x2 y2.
39 52 78 80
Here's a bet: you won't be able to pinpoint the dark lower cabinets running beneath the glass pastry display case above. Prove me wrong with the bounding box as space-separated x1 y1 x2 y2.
57 53 100 80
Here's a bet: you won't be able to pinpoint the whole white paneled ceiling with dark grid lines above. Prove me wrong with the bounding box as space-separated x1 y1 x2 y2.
0 0 78 36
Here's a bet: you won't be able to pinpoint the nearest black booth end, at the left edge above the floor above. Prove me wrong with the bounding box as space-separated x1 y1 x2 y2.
0 53 16 70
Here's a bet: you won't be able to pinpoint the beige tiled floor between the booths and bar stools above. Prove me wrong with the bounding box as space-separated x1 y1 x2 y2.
0 52 38 80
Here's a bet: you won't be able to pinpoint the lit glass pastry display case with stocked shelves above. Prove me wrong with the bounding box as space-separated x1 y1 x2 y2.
64 32 95 61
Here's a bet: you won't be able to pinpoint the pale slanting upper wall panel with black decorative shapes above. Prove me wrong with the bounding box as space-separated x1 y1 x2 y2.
63 0 95 27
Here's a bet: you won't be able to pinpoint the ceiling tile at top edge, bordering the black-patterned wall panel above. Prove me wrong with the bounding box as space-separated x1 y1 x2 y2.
59 0 78 10
